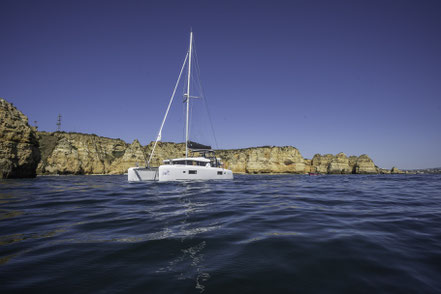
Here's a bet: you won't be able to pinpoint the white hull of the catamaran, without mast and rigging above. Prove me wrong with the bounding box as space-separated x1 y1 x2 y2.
128 165 233 182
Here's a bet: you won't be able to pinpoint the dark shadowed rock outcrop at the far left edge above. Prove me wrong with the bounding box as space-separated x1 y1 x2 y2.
0 98 40 178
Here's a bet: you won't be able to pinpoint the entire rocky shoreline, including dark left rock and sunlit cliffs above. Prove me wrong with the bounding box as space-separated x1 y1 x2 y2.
0 98 404 178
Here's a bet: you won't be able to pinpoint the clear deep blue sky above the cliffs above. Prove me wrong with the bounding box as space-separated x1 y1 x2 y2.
0 0 441 168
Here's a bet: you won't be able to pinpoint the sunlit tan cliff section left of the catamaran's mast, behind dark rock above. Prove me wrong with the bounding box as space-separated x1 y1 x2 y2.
38 132 185 175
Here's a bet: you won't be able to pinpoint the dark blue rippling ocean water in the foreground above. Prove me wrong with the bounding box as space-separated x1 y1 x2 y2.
0 175 441 293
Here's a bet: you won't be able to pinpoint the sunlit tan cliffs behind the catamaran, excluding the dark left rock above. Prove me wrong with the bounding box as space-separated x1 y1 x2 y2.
38 132 380 174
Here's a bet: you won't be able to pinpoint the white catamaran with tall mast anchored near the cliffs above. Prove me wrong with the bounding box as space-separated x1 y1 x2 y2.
128 32 233 182
